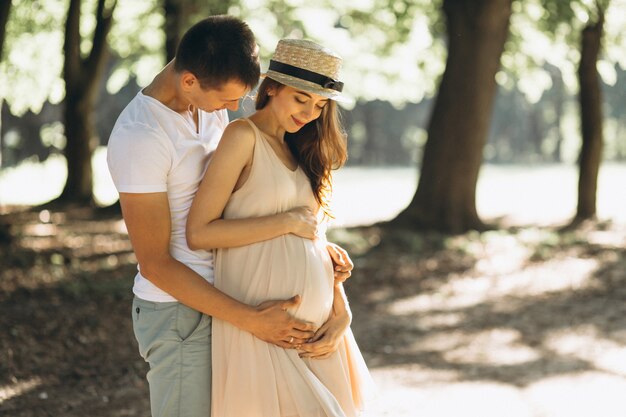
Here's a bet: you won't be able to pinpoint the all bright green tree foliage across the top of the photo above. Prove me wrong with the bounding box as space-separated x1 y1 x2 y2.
0 0 626 114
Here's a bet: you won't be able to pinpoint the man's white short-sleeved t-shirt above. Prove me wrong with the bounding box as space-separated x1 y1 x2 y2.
107 91 228 302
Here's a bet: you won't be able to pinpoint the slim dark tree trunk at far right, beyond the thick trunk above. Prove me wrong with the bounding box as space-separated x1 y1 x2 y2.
573 14 604 223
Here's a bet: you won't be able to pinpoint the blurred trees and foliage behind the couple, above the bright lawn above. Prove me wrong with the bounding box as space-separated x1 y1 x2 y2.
0 0 626 231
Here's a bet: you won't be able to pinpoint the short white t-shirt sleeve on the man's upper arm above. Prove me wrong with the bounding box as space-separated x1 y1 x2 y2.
107 125 173 193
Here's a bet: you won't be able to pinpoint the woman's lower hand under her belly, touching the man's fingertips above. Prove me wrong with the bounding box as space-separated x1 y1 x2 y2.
296 311 352 359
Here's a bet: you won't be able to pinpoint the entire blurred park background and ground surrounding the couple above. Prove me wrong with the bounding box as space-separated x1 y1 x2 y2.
0 0 626 417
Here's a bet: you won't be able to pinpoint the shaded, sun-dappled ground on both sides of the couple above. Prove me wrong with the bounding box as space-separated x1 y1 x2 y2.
0 206 626 417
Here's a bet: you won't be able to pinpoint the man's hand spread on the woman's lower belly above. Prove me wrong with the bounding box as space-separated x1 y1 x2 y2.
245 295 315 349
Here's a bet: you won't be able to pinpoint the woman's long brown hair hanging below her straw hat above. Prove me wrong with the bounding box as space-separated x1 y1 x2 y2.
255 78 348 217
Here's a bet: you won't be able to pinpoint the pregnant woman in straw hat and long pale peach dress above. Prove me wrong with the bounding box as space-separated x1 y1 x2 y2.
187 39 371 417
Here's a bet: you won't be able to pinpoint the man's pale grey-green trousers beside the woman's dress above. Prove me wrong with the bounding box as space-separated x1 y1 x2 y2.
132 297 211 417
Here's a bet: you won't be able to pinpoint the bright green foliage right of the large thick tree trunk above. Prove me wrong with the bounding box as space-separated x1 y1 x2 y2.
498 0 626 103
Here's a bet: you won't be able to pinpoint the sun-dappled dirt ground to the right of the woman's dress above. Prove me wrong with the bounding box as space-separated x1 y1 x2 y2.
346 226 626 417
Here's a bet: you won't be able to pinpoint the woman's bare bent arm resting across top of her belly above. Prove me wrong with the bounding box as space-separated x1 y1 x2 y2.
186 121 317 250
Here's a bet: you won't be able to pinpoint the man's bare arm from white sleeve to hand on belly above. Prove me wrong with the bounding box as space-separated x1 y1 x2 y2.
120 193 314 348
